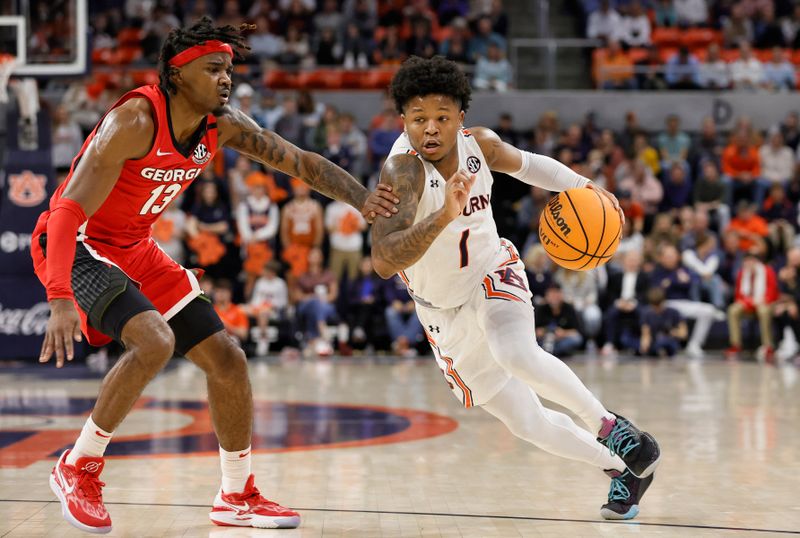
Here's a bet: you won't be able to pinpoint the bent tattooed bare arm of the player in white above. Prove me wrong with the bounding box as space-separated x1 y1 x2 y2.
372 151 475 278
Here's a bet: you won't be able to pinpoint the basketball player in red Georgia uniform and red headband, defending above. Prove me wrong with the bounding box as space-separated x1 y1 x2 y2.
32 18 397 533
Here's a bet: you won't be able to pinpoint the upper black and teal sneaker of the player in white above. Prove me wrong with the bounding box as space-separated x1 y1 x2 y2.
597 413 661 478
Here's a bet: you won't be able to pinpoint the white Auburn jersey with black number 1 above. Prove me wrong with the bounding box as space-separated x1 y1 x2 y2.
389 129 503 308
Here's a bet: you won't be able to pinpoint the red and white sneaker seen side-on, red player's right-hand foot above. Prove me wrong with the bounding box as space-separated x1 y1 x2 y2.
208 475 300 529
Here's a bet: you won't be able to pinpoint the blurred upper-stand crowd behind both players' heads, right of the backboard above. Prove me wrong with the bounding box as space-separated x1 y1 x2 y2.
84 0 511 90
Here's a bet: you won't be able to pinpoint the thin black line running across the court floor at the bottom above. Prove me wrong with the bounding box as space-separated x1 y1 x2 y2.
0 499 800 535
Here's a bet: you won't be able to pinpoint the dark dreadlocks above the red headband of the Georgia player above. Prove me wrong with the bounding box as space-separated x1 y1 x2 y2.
158 16 255 94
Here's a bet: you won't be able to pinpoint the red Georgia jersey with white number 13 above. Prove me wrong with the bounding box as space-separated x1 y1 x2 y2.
35 85 217 247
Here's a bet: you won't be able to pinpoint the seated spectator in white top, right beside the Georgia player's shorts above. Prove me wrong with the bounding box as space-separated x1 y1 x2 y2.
247 260 289 356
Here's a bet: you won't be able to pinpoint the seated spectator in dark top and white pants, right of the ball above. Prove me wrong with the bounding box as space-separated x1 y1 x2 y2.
650 243 724 358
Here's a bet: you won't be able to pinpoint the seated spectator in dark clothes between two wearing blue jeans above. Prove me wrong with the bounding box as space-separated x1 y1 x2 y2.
347 256 388 349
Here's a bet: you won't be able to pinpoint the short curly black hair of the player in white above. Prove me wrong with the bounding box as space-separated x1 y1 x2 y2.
389 56 472 114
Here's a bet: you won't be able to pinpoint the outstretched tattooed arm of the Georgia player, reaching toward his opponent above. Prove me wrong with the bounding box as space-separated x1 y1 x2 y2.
218 107 397 222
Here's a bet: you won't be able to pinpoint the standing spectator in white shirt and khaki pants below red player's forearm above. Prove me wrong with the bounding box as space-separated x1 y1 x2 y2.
325 197 367 282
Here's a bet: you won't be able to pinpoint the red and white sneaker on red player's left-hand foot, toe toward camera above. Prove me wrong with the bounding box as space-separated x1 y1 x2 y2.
50 450 111 534
